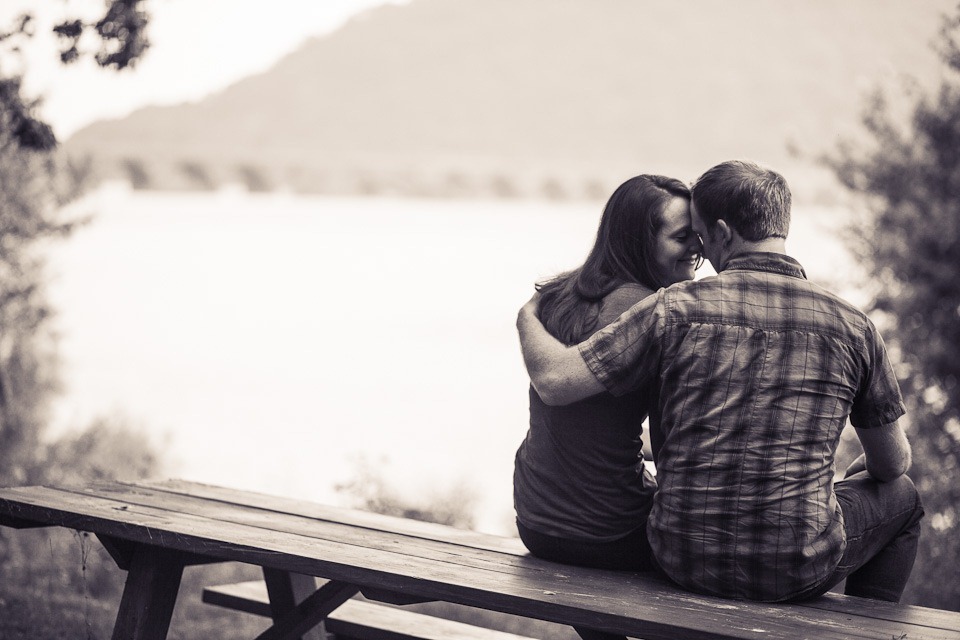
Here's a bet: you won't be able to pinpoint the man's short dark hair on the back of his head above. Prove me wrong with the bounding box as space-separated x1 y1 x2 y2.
692 160 791 242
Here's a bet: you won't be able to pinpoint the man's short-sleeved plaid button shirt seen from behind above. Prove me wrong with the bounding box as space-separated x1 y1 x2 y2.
580 253 904 601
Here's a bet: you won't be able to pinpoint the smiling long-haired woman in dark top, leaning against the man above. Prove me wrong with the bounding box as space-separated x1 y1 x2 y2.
514 175 702 570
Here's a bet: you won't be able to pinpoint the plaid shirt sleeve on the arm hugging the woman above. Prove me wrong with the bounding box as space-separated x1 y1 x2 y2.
579 289 664 396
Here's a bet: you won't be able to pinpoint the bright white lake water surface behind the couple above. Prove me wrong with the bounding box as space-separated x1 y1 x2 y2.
51 189 848 532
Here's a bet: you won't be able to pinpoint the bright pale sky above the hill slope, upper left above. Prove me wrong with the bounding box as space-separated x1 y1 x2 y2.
0 0 407 140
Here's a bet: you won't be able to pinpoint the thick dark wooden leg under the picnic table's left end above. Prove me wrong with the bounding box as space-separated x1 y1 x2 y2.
113 545 184 640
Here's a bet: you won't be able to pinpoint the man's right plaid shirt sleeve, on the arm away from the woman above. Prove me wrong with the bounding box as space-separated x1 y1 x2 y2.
850 320 906 429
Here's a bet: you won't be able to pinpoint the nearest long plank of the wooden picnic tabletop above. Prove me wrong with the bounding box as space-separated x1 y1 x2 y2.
0 488 960 640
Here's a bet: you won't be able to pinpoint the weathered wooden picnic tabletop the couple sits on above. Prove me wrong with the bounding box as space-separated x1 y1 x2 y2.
0 481 960 640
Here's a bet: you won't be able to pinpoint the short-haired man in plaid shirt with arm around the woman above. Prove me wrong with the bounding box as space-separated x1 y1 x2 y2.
517 161 923 601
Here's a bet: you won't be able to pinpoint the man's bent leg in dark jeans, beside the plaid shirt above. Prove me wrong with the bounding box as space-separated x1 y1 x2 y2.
830 471 923 602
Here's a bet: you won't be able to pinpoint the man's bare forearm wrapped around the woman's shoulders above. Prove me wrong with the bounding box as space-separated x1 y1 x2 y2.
517 295 604 405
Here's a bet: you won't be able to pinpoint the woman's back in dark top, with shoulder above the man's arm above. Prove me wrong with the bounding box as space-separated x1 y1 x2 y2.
514 283 656 542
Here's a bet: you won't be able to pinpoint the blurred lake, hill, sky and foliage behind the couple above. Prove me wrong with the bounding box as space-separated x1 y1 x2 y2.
0 0 960 624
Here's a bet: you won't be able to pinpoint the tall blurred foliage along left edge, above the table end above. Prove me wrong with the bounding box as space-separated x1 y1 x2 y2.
0 92 77 484
